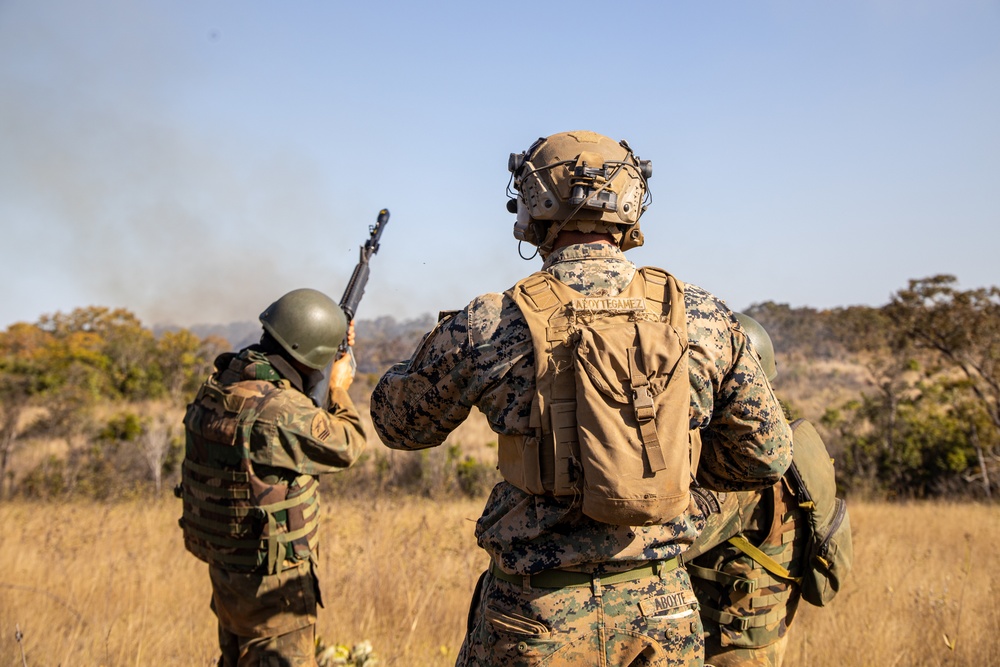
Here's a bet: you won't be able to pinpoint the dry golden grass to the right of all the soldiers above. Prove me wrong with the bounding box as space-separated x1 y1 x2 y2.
787 503 1000 667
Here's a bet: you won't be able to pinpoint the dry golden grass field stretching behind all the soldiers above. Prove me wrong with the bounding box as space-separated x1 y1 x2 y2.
0 497 1000 667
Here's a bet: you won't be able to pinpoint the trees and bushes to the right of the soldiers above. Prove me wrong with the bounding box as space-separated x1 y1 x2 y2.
748 275 1000 498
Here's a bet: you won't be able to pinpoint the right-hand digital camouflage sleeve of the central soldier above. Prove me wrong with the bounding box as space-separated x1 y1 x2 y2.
685 285 792 491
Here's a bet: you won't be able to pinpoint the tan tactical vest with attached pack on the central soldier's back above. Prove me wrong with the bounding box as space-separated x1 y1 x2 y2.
499 267 701 526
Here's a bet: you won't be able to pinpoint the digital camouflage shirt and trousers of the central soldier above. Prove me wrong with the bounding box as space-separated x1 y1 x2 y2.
371 243 791 666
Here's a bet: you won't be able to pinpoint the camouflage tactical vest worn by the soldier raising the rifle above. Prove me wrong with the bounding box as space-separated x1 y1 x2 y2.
179 371 319 574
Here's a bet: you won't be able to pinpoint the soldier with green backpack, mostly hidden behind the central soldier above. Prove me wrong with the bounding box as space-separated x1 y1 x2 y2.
684 313 853 667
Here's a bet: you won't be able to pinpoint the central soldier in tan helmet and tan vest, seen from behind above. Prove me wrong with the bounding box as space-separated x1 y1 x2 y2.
371 132 791 667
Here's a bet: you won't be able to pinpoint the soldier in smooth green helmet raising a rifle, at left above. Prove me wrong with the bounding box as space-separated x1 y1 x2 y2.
179 289 365 667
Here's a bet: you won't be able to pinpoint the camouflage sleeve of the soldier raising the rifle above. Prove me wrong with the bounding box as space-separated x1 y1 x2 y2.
261 389 365 475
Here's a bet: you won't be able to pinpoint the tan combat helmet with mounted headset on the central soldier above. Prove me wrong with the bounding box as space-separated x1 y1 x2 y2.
507 130 653 251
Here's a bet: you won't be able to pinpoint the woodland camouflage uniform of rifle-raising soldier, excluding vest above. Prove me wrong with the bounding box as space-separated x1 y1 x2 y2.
182 346 365 667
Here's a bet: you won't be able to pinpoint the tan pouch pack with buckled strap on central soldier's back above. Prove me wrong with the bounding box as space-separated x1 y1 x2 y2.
575 321 691 526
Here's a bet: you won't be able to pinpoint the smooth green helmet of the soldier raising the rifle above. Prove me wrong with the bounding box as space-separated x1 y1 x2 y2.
260 288 347 370
